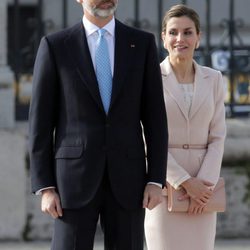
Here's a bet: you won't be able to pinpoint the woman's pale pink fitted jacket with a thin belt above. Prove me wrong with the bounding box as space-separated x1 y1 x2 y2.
161 57 226 188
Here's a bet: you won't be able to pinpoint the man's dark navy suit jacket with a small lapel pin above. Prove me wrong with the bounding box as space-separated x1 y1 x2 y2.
29 20 168 209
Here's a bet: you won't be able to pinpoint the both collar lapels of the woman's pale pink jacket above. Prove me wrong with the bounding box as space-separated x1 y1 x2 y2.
161 57 213 120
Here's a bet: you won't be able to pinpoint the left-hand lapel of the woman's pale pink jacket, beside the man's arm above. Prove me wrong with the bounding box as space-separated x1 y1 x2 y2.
161 57 188 120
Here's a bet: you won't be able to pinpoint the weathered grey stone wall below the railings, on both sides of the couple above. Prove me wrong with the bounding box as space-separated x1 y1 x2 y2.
0 120 250 240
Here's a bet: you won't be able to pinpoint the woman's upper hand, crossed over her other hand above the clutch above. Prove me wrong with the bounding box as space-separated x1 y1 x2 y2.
179 177 214 206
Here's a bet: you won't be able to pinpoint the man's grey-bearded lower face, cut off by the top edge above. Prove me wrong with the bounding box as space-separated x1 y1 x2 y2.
77 0 118 18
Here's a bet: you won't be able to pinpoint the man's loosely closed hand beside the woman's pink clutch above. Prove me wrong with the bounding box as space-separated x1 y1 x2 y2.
143 184 162 210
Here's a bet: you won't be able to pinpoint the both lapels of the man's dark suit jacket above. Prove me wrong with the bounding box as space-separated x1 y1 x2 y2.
65 20 134 113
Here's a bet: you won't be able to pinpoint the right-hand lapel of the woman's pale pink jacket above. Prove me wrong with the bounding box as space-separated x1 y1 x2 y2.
189 62 212 119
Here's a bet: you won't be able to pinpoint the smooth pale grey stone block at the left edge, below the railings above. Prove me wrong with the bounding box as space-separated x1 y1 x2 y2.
0 130 27 239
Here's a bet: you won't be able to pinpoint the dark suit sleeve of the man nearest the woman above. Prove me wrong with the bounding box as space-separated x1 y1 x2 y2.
141 34 168 185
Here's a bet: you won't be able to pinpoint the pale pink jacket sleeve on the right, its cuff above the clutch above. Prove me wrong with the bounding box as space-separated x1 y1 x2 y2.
197 72 226 184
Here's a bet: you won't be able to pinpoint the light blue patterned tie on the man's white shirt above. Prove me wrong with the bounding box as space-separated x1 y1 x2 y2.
95 29 112 114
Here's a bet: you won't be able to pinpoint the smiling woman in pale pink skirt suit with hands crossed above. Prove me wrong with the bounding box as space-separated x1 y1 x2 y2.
145 5 226 250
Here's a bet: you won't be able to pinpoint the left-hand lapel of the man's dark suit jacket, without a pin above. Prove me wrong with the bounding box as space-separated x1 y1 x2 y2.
65 22 104 111
